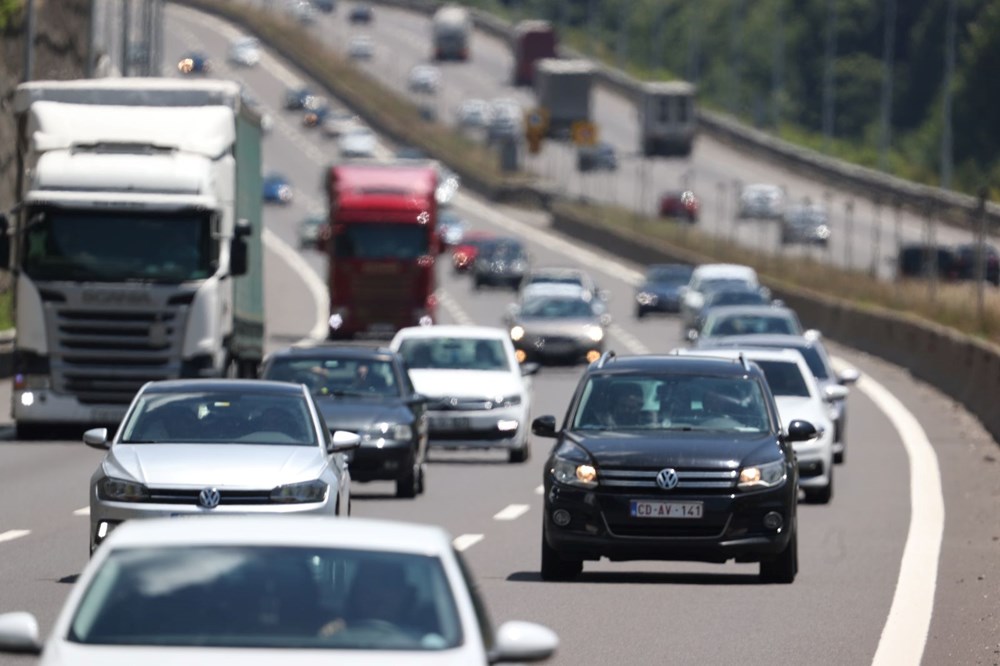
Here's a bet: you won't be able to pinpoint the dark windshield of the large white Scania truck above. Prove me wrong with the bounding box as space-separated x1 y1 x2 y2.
22 210 216 282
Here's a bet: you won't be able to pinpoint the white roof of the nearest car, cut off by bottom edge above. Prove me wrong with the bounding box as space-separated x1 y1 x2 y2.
98 515 451 556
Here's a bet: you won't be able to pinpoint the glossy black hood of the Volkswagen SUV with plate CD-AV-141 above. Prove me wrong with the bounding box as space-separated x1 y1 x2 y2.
572 431 778 470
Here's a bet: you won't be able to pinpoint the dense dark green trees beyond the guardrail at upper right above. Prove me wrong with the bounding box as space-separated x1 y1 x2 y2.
480 0 1000 192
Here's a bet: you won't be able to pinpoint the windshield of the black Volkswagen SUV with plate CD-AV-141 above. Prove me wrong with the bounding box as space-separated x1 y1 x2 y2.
572 374 771 433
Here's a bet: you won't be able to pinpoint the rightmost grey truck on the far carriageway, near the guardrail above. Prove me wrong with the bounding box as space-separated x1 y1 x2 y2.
636 81 698 157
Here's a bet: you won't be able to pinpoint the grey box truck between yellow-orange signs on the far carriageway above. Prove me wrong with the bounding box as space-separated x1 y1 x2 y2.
535 58 594 138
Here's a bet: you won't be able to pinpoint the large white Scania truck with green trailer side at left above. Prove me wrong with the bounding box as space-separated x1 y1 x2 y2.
0 78 264 437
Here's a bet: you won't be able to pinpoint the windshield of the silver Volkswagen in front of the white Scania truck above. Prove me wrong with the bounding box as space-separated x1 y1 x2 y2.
120 391 319 446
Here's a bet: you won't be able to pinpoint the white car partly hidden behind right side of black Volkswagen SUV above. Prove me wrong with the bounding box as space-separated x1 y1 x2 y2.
674 348 848 504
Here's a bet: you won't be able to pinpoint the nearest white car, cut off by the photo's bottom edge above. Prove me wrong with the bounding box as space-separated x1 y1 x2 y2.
0 516 559 666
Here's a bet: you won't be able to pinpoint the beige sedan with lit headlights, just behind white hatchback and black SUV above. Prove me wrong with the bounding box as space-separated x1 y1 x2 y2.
504 285 610 363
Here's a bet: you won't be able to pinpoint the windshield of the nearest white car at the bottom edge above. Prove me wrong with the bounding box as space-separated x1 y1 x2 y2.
68 546 463 648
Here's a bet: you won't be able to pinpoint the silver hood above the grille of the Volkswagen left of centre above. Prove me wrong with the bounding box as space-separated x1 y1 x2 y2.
102 444 328 488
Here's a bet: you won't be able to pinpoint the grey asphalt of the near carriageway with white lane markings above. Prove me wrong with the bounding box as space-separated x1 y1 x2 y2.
0 8 1000 664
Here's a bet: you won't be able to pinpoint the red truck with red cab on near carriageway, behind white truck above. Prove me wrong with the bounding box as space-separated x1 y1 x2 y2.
323 160 440 339
